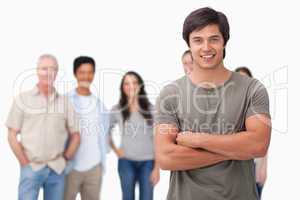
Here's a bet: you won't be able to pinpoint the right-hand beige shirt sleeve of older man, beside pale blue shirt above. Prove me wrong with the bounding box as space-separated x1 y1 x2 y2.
66 98 79 134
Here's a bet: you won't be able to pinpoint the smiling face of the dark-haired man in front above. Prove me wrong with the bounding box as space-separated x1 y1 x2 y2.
189 24 225 69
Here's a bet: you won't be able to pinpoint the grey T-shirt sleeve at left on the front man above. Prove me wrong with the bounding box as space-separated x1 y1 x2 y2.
154 85 180 128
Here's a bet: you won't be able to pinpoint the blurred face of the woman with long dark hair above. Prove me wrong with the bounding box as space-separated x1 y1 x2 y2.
123 75 140 98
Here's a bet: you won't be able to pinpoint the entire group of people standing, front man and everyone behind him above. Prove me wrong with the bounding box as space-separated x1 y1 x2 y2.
6 7 271 200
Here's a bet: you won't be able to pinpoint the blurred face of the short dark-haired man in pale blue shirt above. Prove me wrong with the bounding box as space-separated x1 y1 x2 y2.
75 63 95 88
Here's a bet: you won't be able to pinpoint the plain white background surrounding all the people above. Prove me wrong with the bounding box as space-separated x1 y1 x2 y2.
0 0 300 200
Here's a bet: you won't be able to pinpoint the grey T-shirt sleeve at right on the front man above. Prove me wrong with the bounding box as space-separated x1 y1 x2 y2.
246 80 271 118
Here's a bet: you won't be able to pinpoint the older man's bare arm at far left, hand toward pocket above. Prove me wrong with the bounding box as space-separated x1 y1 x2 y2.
8 128 30 166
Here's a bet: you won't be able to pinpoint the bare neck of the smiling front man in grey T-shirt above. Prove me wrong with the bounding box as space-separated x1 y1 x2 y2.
189 64 231 87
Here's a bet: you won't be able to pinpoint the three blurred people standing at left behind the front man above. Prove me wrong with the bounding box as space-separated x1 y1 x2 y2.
6 54 160 200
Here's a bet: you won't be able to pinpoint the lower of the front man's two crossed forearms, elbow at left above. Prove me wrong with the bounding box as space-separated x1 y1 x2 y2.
158 144 229 171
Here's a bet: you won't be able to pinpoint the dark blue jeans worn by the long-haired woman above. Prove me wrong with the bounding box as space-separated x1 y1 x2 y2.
118 159 154 200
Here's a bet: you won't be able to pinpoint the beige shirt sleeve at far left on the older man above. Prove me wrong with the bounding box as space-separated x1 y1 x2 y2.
6 98 24 131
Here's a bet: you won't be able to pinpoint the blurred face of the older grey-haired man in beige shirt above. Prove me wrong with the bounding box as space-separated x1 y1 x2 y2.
37 58 58 86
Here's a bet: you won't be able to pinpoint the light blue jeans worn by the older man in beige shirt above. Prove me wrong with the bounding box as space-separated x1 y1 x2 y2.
19 165 65 200
